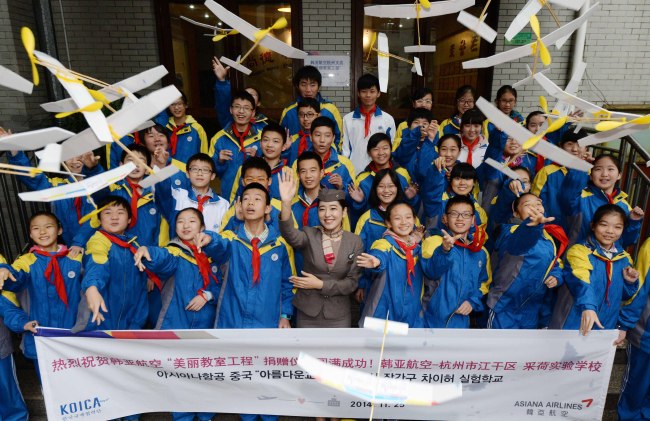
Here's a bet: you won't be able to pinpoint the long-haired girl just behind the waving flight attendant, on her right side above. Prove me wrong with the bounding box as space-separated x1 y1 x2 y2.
354 169 404 303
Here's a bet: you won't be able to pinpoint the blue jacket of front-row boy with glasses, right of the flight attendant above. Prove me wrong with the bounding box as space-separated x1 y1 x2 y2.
422 231 492 329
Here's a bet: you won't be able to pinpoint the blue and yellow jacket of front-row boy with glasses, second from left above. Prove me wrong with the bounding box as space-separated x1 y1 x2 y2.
80 231 149 330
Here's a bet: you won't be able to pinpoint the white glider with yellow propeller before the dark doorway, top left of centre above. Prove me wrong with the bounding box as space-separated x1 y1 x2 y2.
204 0 308 74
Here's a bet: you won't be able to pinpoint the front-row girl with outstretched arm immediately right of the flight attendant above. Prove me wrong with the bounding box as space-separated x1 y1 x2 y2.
357 202 423 327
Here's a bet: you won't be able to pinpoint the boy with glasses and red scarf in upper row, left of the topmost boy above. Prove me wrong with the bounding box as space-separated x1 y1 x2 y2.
208 91 260 198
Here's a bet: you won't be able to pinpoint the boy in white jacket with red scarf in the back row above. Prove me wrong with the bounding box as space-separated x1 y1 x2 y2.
342 74 395 176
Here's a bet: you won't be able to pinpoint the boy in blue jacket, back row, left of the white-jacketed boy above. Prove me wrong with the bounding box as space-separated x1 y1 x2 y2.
280 66 343 147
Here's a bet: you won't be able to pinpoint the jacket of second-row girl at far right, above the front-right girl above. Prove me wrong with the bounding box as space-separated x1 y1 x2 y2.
560 176 643 248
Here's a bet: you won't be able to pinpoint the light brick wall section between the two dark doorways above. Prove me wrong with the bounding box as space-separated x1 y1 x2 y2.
302 0 354 116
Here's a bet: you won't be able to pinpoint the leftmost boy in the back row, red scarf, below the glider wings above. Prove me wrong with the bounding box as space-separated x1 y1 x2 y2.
165 92 208 163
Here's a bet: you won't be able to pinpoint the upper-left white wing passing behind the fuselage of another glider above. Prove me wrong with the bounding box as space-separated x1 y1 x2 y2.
41 65 168 113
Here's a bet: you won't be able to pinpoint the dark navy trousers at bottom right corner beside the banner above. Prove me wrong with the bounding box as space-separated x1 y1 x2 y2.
618 343 650 421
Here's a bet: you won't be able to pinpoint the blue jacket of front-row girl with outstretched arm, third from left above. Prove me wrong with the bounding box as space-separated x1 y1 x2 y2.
143 239 221 329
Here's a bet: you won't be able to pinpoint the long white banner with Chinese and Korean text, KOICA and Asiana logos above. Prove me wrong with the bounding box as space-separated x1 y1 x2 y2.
36 328 617 421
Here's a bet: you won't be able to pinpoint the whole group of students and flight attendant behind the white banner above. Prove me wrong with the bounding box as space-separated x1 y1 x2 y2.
0 59 650 420
